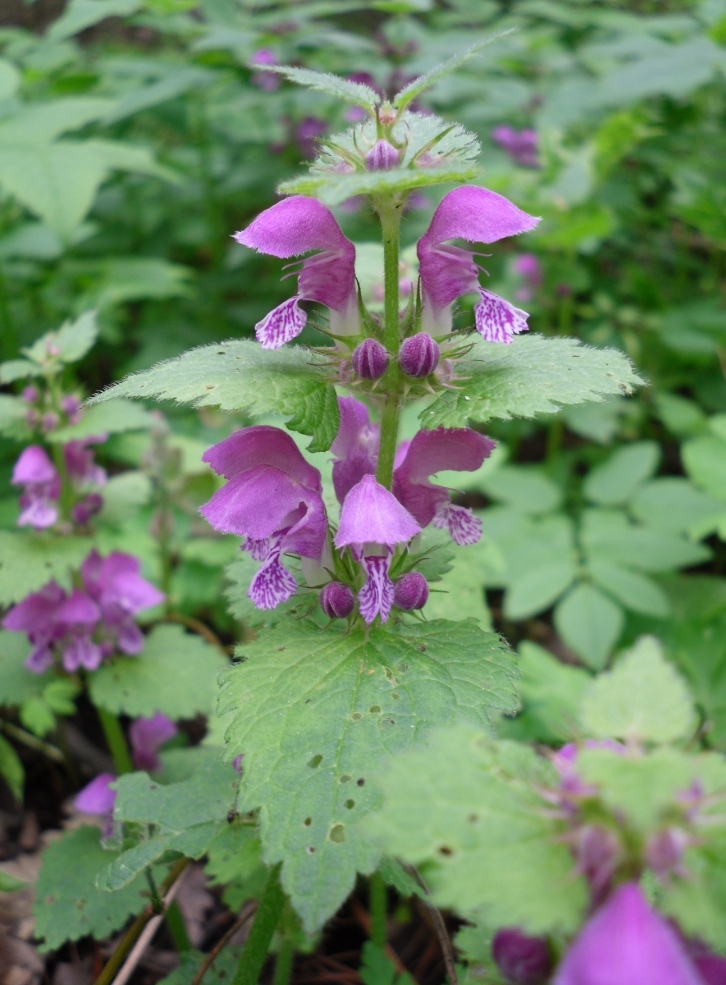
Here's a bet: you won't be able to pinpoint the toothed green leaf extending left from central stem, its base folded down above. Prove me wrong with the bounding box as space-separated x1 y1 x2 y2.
90 339 340 451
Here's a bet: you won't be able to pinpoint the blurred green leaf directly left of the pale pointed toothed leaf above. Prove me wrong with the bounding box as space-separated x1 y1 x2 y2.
498 641 592 742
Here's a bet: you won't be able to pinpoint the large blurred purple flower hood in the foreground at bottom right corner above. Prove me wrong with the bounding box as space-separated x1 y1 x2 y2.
553 882 703 985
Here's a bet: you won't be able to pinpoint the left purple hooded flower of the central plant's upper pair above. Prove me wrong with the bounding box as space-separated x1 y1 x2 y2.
234 195 359 349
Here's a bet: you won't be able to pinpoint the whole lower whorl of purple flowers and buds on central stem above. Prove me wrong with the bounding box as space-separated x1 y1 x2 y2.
201 397 494 623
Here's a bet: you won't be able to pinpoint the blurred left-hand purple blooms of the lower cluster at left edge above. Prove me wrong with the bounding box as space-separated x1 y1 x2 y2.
2 581 103 674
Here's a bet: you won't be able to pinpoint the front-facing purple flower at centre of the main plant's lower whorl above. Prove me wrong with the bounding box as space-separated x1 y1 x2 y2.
335 475 421 624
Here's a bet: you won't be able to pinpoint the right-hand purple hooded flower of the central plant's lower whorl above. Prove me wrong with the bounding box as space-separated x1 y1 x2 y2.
393 428 496 547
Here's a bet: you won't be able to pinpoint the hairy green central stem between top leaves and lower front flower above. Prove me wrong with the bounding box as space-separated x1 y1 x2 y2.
376 199 401 489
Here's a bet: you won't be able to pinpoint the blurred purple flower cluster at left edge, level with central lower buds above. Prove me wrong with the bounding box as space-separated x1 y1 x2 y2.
2 551 163 674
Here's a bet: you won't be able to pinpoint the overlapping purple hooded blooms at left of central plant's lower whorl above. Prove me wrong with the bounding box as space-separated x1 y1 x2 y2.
200 425 328 609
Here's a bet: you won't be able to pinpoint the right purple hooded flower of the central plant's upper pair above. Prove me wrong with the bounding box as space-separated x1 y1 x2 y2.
417 185 539 343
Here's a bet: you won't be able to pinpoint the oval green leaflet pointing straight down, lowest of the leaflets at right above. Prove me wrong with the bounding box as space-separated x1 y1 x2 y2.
555 582 625 670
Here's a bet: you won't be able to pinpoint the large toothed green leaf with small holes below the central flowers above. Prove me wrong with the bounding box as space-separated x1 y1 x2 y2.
220 620 516 930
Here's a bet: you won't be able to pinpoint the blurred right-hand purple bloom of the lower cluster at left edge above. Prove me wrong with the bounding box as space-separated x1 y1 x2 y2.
81 551 164 657
